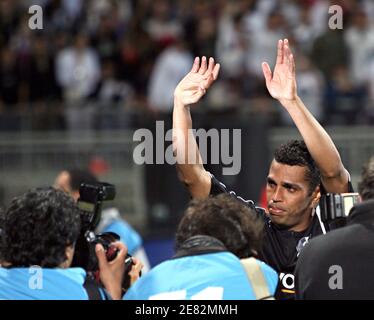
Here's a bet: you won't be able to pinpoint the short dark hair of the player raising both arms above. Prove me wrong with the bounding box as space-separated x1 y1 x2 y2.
274 140 321 194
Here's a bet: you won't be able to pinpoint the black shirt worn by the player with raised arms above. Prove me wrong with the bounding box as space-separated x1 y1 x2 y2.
210 175 351 299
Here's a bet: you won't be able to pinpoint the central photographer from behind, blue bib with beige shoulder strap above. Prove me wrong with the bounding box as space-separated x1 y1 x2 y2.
124 195 278 300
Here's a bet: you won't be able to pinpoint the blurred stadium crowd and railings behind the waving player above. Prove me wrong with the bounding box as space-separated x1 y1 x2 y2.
0 0 374 263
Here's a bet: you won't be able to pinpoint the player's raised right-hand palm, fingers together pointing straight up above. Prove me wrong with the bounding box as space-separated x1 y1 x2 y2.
262 39 297 102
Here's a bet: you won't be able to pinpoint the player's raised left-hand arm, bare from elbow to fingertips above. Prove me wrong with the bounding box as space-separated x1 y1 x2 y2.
173 57 220 198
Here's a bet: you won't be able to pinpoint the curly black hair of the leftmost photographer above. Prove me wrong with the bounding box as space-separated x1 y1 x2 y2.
0 187 80 268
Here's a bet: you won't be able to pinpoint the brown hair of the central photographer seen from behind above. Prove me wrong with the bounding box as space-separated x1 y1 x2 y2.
176 194 263 258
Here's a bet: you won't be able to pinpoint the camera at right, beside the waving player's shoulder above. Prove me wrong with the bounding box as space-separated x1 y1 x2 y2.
319 193 360 226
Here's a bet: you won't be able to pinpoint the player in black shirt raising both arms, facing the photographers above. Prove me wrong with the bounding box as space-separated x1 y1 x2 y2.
173 39 350 298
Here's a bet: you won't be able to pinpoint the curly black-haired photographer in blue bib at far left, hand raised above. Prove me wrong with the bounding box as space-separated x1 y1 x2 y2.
0 187 127 300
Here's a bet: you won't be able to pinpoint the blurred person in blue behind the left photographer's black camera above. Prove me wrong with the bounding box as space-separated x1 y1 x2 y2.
55 169 150 273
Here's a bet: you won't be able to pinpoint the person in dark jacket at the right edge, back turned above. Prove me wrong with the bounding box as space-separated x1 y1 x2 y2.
295 158 374 300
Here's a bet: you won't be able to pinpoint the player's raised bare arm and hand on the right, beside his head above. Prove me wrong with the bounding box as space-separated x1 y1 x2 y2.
262 39 349 193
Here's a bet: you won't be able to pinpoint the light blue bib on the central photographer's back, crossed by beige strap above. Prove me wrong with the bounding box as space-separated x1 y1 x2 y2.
123 252 278 300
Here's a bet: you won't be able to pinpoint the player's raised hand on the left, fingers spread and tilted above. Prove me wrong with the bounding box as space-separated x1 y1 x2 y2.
174 57 220 106
